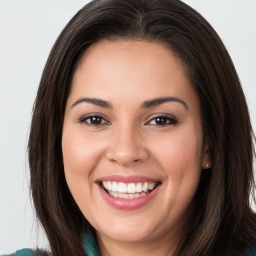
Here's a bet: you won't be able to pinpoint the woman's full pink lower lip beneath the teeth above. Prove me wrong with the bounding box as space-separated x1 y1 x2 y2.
98 185 160 210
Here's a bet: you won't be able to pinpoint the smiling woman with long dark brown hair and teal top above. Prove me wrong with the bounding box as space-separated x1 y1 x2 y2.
4 0 256 256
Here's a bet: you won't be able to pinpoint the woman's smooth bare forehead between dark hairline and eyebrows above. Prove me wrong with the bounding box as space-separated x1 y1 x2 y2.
71 40 196 109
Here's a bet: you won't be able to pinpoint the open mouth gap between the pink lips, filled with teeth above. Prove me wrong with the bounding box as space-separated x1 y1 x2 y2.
100 181 161 199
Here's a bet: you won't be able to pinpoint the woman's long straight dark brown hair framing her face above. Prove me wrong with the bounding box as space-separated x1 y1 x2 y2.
28 0 256 256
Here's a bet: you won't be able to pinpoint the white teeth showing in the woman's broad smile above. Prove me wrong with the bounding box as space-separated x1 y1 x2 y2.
102 181 157 195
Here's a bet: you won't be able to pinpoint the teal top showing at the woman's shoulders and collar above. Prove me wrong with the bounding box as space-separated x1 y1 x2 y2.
2 233 256 256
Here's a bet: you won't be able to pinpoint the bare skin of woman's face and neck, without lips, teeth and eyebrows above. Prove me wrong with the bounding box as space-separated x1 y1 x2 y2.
62 40 210 256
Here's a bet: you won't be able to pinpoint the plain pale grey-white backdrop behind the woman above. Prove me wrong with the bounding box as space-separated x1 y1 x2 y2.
0 0 256 254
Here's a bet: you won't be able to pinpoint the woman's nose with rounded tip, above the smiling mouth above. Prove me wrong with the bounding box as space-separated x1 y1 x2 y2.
107 124 149 166
